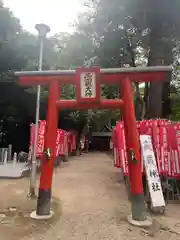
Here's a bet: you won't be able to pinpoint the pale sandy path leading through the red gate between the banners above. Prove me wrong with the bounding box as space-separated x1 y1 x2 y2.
0 153 180 240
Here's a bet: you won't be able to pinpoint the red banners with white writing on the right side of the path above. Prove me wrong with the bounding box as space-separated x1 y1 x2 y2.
113 119 180 179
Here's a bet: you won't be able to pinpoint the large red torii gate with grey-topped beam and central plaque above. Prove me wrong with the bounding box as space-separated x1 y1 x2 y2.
15 66 172 221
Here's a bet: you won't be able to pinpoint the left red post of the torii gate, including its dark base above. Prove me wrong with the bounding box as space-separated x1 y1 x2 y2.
36 80 60 215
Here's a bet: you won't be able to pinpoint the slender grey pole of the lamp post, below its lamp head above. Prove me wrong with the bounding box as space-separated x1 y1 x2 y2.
29 37 44 197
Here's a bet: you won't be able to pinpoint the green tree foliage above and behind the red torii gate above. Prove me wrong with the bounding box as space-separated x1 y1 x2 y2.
0 0 180 132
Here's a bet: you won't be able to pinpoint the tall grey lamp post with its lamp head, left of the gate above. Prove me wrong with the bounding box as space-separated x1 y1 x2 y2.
29 23 50 198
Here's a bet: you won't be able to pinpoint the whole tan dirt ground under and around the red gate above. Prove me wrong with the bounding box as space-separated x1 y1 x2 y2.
0 153 180 240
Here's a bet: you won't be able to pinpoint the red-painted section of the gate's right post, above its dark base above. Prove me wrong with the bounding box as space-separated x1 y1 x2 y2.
121 78 143 195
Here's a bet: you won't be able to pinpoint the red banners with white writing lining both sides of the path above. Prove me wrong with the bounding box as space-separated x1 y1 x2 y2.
30 119 180 178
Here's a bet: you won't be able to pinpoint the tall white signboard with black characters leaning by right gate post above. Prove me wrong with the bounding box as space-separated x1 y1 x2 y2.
140 135 165 208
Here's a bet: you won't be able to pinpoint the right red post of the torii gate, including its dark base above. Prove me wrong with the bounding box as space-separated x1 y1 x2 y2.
121 78 146 221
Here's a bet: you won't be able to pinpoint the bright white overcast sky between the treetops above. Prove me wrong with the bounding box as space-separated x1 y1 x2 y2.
4 0 83 34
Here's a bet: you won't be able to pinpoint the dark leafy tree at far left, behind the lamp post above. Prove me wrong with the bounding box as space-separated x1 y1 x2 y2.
0 2 35 151
